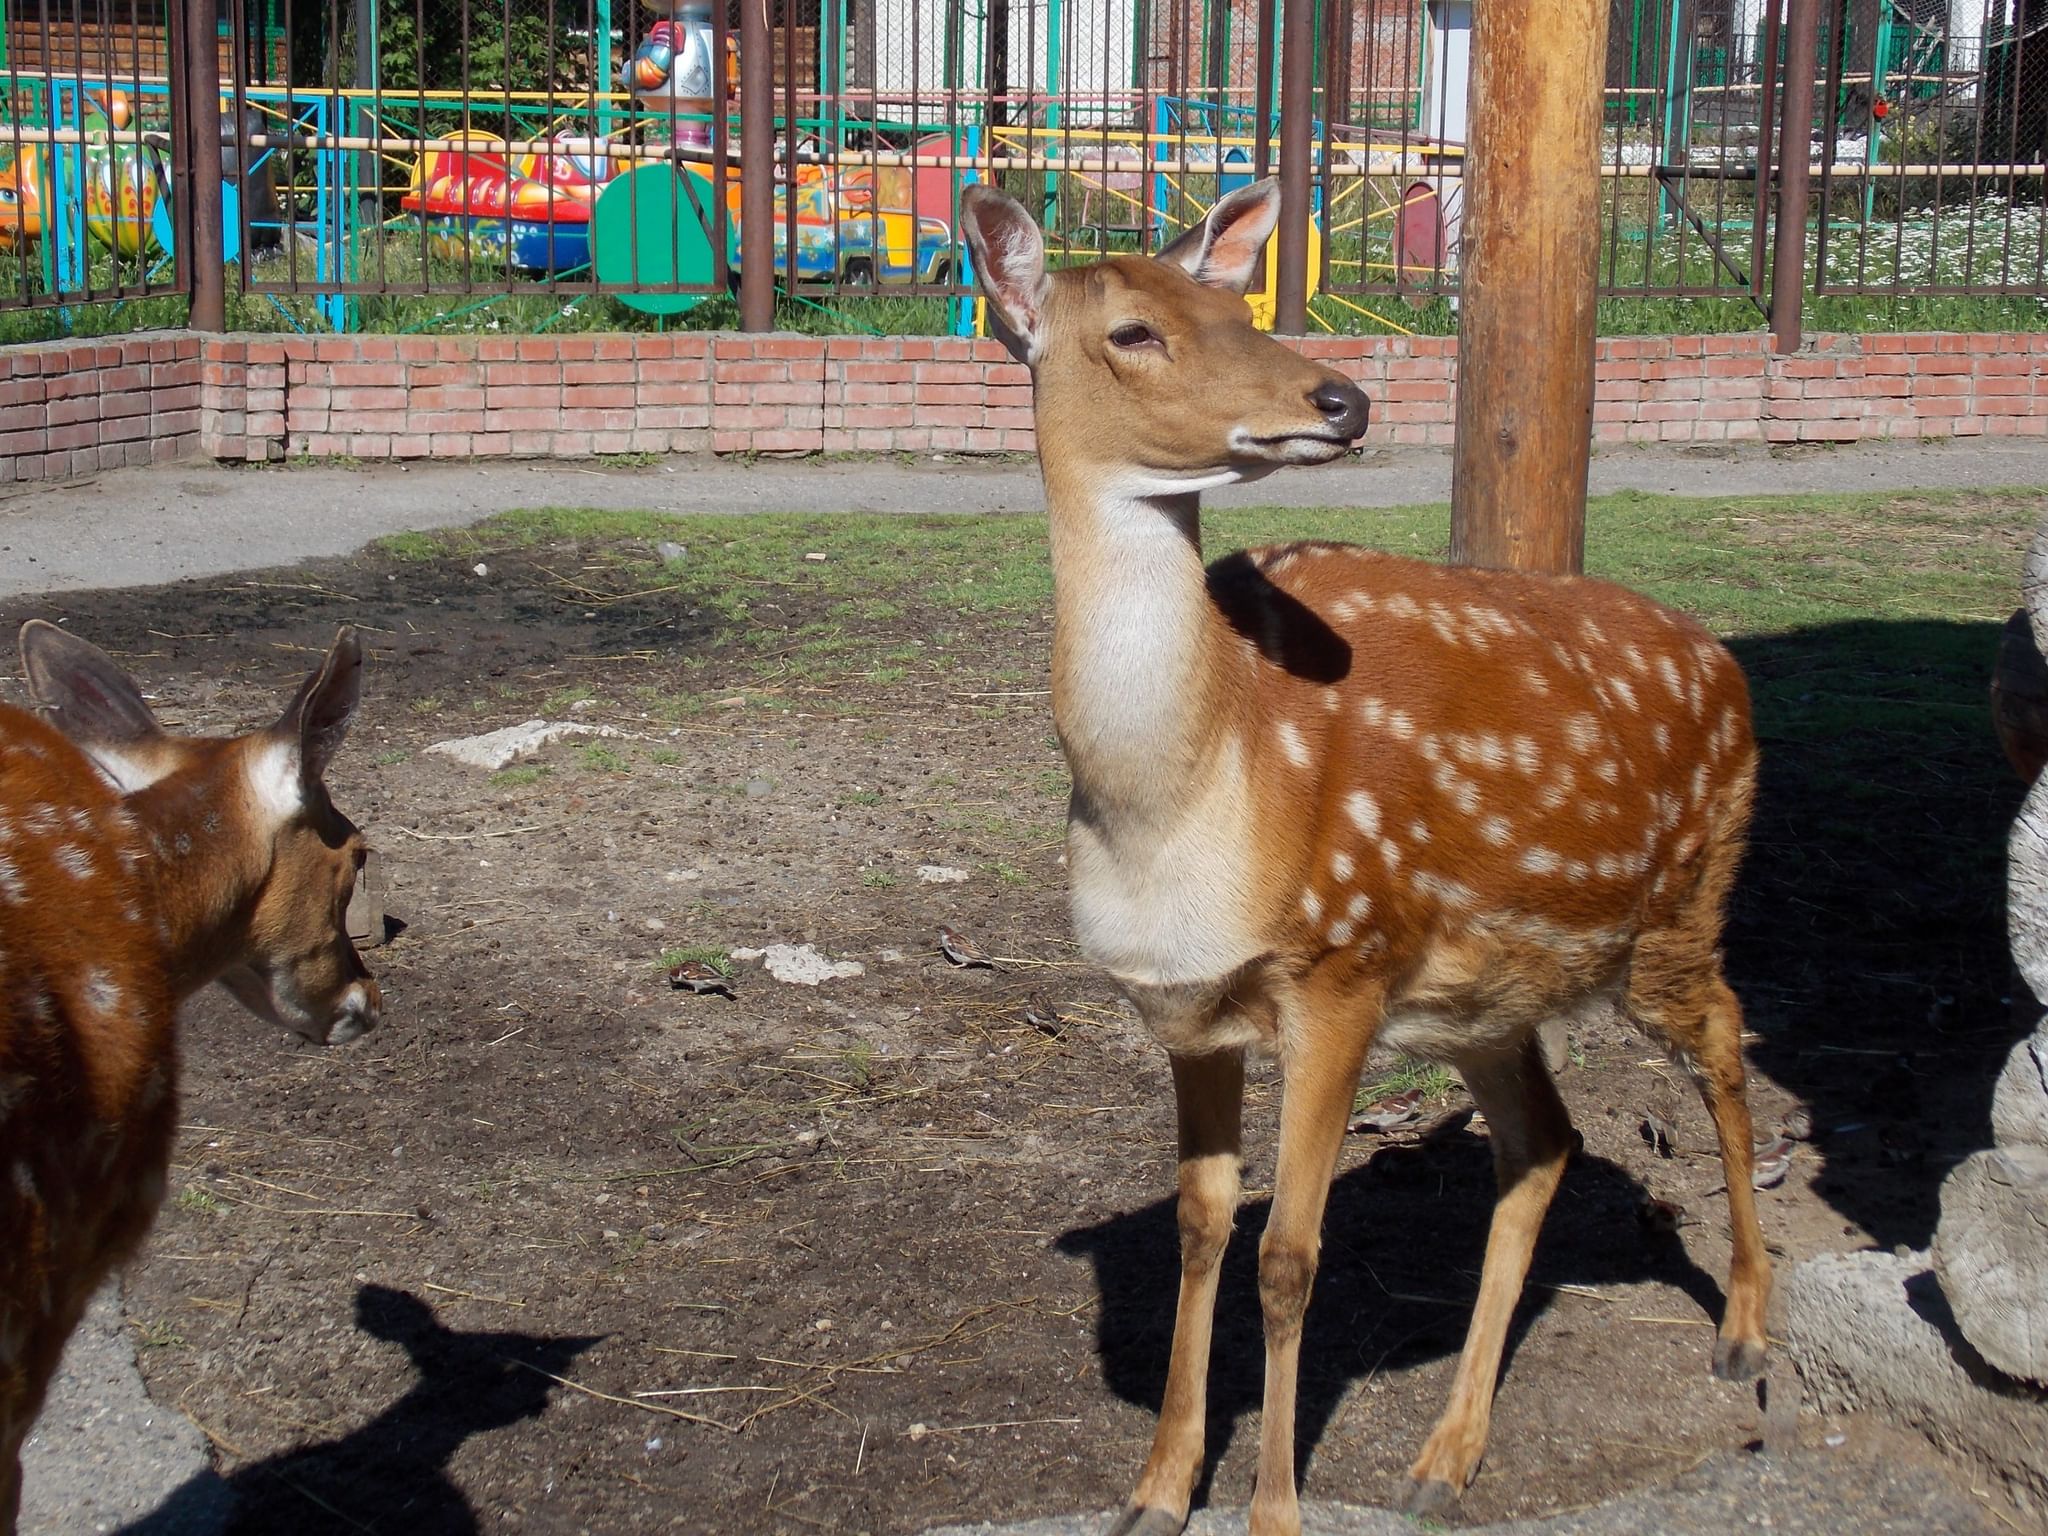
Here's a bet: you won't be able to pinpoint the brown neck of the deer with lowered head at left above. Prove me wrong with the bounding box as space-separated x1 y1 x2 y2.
125 764 268 1001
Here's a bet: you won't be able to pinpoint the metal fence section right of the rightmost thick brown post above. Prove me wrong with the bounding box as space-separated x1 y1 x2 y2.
1812 0 2048 297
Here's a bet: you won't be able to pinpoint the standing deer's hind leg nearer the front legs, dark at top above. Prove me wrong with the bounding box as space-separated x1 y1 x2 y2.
1401 1036 1573 1516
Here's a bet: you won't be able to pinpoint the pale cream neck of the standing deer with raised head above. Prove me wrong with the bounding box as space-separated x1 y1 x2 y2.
1044 467 1219 823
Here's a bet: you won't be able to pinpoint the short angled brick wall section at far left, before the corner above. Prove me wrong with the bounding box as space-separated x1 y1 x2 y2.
0 334 201 481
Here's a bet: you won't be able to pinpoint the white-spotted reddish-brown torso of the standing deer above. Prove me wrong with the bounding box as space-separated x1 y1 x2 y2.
1210 545 1755 1024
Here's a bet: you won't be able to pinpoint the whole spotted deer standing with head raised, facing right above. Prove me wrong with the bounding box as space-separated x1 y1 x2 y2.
963 182 1769 1536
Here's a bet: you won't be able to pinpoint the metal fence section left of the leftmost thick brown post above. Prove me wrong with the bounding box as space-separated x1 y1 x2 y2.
0 0 190 325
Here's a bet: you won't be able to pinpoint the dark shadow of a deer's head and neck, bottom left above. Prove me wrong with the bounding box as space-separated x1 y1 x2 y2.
117 1286 600 1536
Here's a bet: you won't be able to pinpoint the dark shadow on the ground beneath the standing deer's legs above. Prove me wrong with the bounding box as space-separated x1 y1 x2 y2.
1059 1128 1722 1505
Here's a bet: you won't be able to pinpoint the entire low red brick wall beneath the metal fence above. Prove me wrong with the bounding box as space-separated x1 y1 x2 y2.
0 332 2048 479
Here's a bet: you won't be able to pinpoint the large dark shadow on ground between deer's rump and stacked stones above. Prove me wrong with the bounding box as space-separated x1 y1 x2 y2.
1726 621 2023 1247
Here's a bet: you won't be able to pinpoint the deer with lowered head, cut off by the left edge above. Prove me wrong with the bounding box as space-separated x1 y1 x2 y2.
0 623 381 1536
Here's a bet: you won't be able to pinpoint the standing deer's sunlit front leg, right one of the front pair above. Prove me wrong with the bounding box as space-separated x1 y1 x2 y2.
1251 1001 1372 1536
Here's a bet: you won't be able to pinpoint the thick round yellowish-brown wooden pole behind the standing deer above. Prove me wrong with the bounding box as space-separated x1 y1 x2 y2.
1450 0 1608 571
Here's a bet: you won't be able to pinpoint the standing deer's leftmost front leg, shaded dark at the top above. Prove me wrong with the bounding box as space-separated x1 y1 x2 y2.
1112 1051 1245 1536
